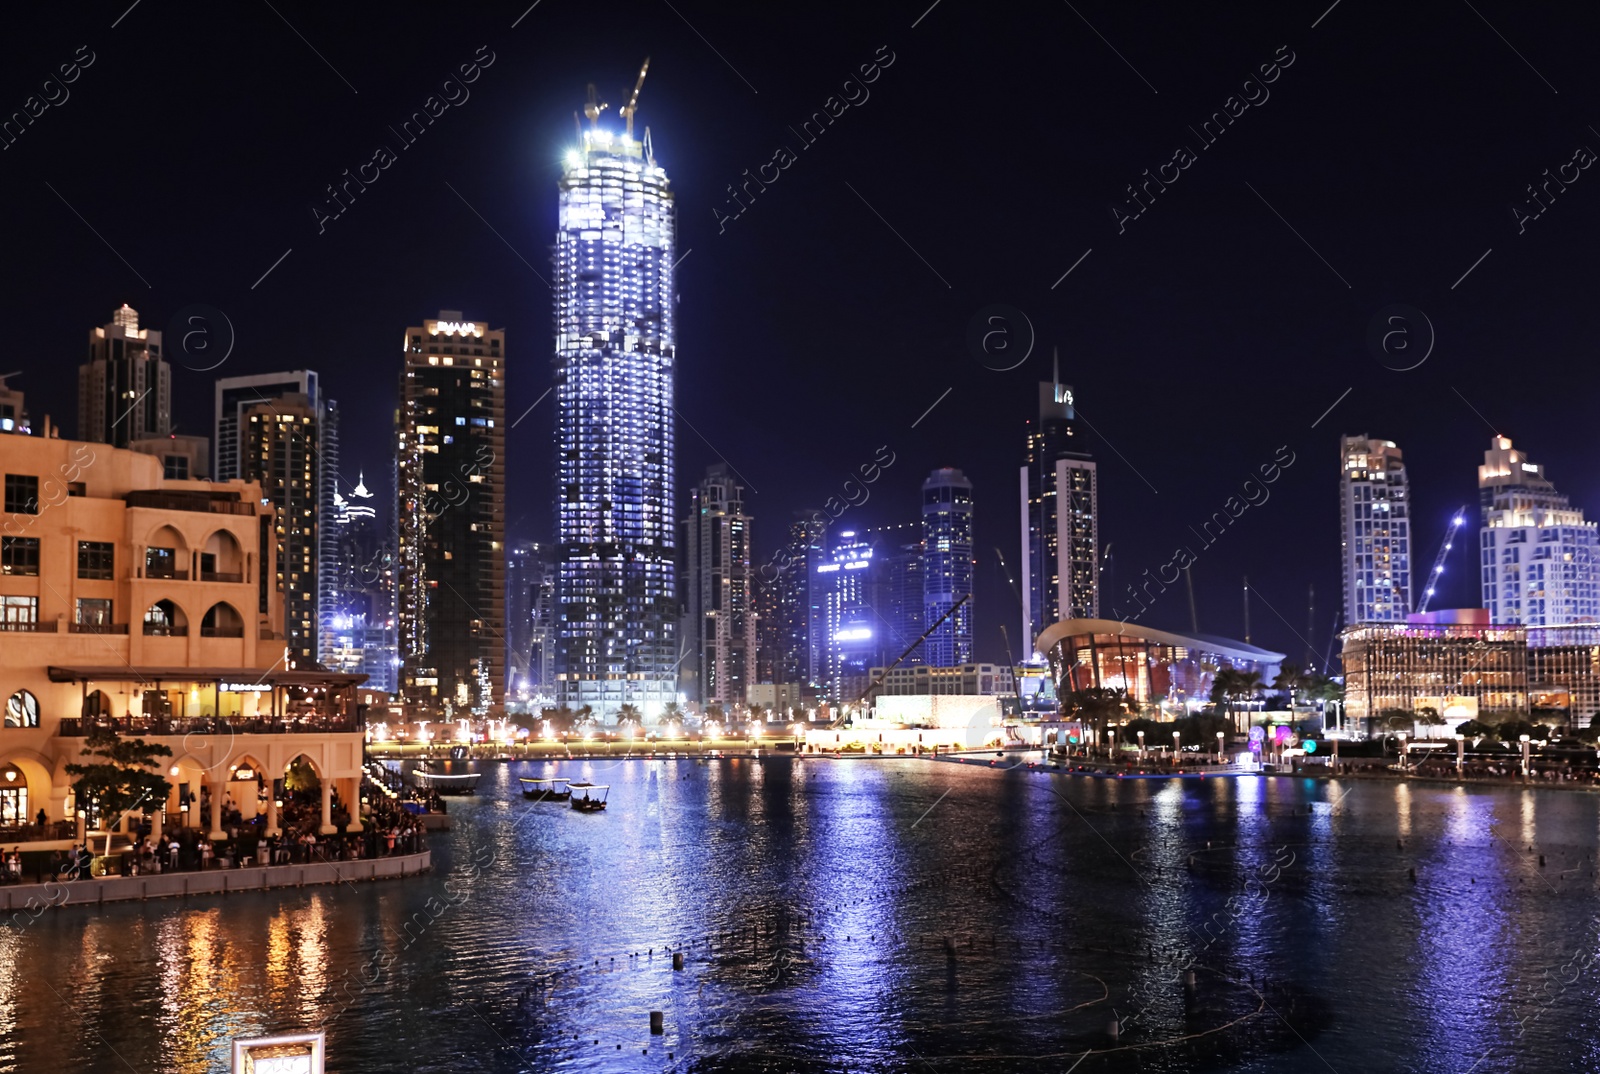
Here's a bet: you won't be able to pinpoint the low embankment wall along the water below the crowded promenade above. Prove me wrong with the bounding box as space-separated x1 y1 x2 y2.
0 850 434 920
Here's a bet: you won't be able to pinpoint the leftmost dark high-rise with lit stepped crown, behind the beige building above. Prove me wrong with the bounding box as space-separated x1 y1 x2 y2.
78 303 173 448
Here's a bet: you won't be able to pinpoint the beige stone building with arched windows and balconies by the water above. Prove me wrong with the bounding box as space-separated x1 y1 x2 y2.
0 423 365 842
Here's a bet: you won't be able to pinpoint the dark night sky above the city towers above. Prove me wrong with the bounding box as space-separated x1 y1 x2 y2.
0 0 1600 672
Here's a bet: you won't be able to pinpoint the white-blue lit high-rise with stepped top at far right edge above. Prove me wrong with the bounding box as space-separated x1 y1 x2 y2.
1478 435 1600 627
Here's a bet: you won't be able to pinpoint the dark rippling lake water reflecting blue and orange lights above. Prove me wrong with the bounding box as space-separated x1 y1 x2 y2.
0 759 1600 1074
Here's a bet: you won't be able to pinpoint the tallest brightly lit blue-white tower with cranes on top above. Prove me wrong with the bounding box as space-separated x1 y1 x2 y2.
555 72 677 719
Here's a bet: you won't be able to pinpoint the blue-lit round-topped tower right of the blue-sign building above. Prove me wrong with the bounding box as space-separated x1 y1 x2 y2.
922 467 973 667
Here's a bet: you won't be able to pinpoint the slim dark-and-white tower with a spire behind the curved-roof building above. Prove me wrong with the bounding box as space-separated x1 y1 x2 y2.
1021 368 1099 655
